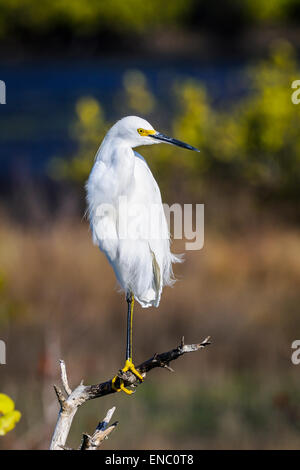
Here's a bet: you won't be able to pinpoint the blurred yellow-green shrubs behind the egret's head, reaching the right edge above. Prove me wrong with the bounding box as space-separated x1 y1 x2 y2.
52 42 300 197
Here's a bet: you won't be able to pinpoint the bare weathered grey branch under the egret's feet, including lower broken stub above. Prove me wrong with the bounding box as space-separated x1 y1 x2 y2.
50 337 210 450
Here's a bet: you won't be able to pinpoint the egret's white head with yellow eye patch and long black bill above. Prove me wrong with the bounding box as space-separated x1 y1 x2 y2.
109 116 200 152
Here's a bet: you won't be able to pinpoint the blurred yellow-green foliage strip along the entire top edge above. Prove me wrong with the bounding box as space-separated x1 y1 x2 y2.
0 0 298 39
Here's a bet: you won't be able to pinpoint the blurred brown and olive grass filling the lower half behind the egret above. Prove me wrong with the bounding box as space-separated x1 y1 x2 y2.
0 197 300 449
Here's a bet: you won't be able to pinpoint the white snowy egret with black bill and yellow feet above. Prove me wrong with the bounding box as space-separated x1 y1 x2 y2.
86 116 199 394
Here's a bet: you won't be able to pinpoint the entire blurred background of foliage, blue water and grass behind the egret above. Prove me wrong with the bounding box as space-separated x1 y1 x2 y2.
0 0 300 449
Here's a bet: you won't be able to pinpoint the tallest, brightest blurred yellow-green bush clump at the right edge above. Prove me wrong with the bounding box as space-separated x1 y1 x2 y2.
236 43 300 193
